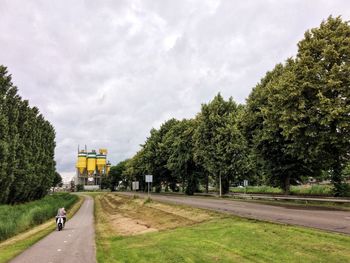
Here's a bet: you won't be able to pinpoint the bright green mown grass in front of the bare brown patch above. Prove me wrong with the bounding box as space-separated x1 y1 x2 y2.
97 217 350 262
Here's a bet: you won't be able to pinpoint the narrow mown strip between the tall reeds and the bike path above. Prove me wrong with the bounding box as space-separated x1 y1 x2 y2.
0 196 84 263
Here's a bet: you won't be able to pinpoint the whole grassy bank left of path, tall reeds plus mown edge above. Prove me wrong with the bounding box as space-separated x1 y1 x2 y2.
0 193 84 263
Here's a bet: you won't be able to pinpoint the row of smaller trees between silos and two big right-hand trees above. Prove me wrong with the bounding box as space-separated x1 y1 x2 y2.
124 94 249 195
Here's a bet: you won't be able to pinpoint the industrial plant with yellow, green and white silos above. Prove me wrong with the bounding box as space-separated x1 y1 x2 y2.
75 146 111 190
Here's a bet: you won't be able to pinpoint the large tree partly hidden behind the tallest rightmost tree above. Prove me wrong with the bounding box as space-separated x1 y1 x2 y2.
243 62 313 194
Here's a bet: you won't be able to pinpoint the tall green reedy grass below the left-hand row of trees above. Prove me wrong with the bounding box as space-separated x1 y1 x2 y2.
0 193 78 241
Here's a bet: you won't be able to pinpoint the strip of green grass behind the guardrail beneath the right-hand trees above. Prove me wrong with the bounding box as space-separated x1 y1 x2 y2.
230 185 333 196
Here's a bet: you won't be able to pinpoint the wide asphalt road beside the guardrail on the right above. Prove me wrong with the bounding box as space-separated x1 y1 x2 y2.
123 193 350 235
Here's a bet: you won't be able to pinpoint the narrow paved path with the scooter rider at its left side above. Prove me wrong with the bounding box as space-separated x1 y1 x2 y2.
10 196 96 263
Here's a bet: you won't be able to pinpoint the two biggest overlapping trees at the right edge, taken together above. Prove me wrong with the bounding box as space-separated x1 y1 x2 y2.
242 14 350 195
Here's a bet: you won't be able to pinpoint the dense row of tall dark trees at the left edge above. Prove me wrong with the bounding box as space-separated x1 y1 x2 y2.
0 65 56 203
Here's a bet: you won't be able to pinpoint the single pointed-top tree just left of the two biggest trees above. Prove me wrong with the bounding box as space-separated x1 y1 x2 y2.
194 94 244 194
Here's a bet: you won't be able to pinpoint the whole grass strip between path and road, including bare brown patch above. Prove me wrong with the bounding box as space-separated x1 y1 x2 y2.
94 194 350 262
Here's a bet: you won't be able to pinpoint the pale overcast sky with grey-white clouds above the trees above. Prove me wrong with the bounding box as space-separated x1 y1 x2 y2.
0 0 350 183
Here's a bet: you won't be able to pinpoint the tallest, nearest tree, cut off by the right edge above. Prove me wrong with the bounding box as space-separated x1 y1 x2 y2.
272 14 350 195
